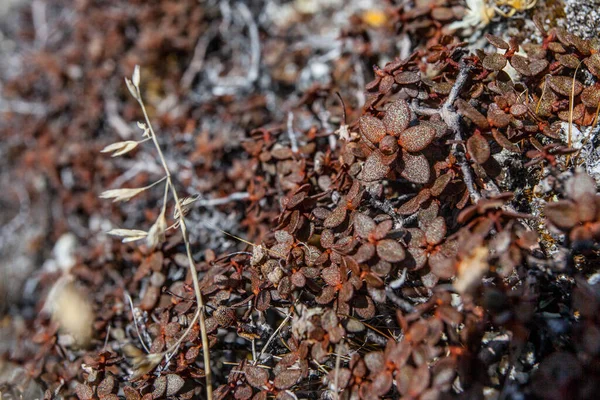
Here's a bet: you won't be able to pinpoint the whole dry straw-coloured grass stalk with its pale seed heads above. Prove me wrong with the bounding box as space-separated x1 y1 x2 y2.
100 66 213 400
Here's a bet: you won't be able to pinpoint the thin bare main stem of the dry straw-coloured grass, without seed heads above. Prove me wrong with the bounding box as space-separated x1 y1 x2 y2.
136 86 213 400
